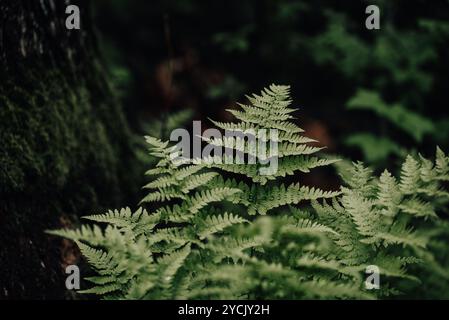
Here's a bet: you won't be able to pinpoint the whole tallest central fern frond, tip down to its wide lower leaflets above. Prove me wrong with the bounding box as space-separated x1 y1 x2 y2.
207 85 339 211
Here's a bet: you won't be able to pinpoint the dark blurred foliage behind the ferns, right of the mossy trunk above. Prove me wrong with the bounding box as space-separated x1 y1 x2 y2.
95 0 449 168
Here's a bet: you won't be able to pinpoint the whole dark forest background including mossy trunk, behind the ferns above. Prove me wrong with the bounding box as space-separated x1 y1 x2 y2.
0 0 449 299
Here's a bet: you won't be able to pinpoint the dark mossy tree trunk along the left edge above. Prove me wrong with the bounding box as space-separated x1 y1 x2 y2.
0 0 135 299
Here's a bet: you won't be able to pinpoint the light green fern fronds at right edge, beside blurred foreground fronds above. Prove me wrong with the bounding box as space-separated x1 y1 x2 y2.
314 150 448 288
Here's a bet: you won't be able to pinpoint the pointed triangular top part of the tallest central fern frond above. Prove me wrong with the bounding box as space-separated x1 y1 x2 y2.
208 85 336 184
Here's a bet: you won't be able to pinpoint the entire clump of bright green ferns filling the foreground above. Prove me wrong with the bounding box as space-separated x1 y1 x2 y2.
50 85 449 299
